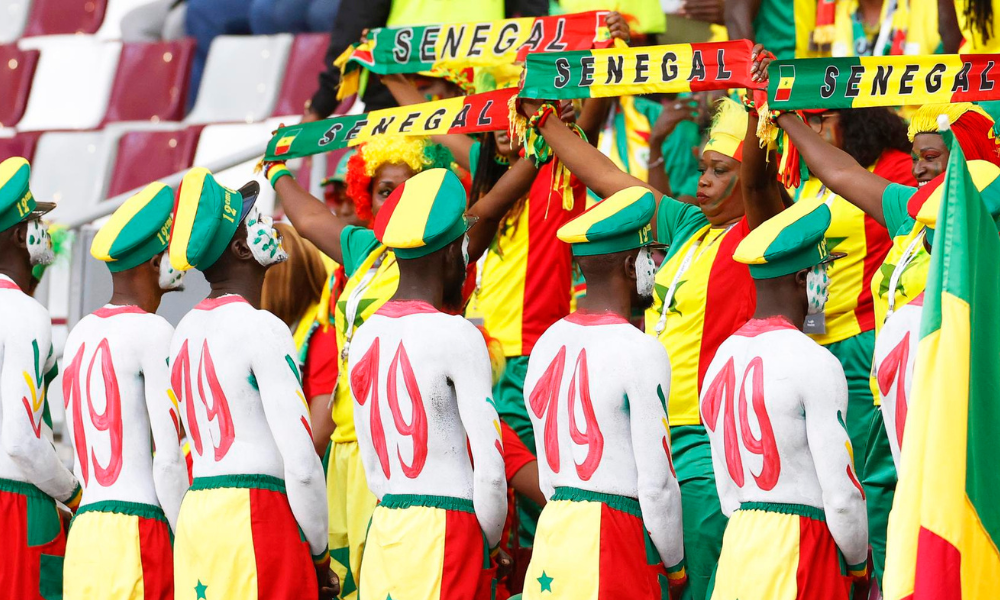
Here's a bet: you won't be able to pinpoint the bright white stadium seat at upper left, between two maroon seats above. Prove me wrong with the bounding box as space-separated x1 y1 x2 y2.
17 35 121 131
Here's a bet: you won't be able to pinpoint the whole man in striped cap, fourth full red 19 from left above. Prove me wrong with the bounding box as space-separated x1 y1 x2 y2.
523 186 687 600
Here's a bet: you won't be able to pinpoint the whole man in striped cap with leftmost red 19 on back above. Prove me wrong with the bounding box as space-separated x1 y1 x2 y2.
63 183 188 600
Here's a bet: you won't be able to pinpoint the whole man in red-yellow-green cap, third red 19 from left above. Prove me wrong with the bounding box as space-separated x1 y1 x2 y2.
348 169 509 600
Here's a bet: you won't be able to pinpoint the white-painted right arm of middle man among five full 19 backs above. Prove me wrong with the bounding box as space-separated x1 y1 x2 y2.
448 324 507 548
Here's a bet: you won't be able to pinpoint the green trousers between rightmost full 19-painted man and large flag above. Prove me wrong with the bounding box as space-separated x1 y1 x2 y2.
859 408 896 582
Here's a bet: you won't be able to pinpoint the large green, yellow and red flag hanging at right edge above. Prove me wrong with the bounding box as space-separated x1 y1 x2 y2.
884 124 1000 600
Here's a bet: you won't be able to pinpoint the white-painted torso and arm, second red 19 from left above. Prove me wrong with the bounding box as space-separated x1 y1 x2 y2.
170 295 328 556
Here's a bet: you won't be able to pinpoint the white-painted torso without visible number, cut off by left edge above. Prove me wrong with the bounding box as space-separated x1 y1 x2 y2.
0 275 77 502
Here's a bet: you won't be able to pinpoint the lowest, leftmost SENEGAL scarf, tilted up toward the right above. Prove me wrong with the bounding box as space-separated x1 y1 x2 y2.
264 88 517 161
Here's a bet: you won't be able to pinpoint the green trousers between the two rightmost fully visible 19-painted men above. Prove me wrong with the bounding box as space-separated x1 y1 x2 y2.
670 425 728 600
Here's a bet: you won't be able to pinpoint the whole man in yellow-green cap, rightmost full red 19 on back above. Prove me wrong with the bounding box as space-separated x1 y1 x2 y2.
700 198 868 600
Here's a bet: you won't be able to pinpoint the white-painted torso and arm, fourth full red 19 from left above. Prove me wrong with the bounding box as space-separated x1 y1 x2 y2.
524 313 684 568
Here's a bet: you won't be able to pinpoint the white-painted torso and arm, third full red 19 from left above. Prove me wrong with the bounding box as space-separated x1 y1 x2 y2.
348 301 507 547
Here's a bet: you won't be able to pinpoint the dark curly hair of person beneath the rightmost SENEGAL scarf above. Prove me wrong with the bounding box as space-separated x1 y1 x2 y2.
837 107 911 167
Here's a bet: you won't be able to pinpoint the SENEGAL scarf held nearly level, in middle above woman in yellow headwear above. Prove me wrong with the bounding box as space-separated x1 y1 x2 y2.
520 40 756 100
